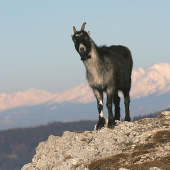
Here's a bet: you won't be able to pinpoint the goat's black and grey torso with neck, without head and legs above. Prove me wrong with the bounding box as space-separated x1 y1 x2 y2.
84 41 133 92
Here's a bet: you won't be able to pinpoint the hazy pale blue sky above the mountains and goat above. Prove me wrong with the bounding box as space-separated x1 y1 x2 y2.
0 0 170 94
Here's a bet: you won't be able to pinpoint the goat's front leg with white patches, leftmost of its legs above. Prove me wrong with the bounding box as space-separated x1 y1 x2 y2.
93 89 105 130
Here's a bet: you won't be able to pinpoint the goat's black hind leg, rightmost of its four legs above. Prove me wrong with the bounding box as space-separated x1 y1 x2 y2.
123 90 131 122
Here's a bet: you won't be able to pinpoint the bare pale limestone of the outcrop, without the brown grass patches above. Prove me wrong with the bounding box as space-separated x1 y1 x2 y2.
22 111 170 170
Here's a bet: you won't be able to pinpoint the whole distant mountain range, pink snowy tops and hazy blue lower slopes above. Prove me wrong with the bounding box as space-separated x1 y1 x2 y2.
0 63 170 129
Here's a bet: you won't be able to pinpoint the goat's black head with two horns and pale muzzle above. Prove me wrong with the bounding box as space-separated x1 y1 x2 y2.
72 22 91 61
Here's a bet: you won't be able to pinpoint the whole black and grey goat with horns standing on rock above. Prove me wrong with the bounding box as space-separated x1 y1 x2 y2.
72 22 133 129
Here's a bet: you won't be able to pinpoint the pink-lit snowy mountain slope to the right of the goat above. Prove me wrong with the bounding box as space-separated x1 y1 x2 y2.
131 63 170 99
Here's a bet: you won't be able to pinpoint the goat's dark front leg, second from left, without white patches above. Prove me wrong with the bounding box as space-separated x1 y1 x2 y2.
106 90 116 128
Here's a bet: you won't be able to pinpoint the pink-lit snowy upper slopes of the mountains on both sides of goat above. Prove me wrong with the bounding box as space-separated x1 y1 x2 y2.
0 63 170 111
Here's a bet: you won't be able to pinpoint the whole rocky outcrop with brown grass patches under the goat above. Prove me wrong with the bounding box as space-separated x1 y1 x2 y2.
22 111 170 170
